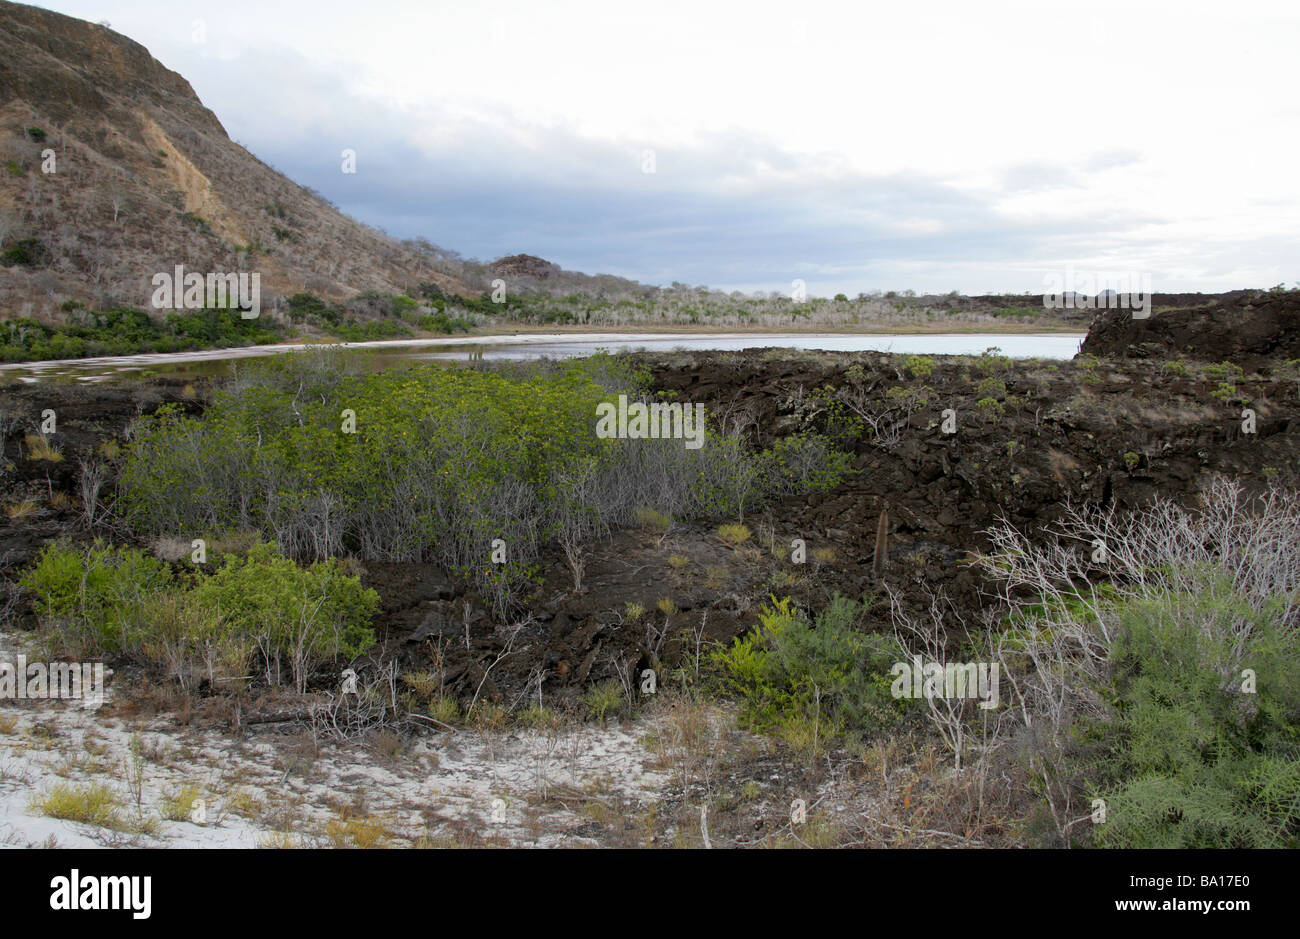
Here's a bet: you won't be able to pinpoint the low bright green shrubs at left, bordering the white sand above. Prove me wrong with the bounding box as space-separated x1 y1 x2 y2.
22 544 380 691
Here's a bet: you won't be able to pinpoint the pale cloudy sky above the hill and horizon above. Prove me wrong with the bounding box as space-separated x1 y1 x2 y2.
27 0 1300 295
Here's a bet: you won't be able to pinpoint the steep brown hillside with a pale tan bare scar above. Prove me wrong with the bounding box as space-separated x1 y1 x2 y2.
0 0 476 320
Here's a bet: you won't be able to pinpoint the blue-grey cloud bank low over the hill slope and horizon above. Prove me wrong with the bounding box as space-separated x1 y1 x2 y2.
162 41 1227 293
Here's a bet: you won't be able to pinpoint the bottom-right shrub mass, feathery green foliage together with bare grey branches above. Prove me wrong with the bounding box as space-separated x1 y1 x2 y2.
980 479 1300 848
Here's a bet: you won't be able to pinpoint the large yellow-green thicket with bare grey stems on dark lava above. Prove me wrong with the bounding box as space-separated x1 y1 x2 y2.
121 352 848 613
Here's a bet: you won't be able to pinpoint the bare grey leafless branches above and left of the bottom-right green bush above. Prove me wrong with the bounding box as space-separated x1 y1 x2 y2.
978 477 1300 839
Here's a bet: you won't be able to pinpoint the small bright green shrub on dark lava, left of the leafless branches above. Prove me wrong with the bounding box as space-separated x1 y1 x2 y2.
711 594 909 739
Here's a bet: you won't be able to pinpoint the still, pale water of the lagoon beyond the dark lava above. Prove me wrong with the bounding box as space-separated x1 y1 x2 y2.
0 333 1083 381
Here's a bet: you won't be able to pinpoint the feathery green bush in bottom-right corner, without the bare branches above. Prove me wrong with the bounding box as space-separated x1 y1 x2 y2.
1082 583 1300 848
